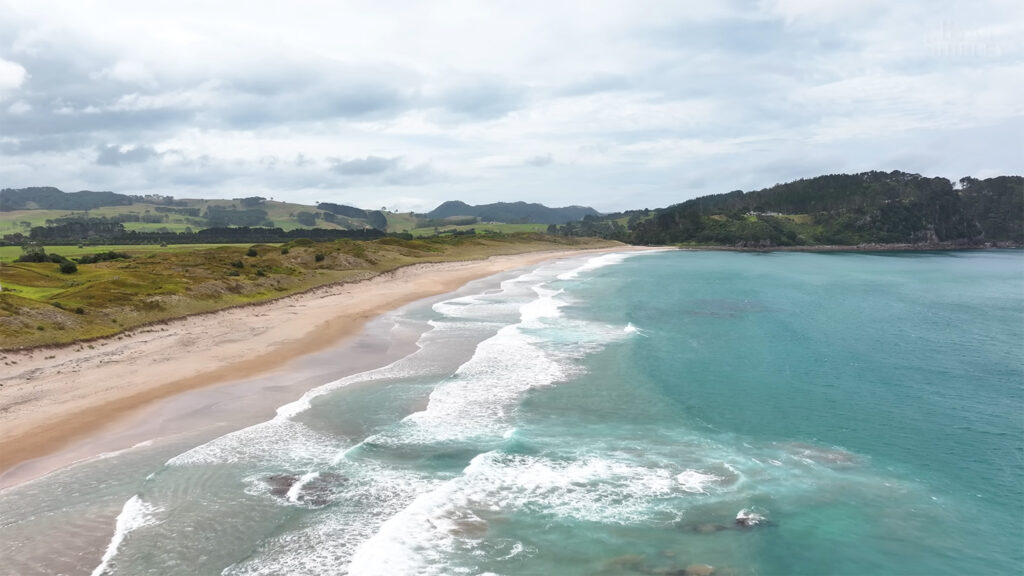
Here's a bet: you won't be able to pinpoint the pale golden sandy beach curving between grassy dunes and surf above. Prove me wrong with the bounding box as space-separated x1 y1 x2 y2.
0 246 651 488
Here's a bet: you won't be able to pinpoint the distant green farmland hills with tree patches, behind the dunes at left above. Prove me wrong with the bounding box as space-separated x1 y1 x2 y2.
0 187 598 238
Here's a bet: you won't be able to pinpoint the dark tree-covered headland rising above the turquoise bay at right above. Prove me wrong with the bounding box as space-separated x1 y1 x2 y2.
559 171 1024 247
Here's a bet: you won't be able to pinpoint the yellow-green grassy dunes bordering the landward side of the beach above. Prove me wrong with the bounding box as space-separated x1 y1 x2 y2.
0 234 615 349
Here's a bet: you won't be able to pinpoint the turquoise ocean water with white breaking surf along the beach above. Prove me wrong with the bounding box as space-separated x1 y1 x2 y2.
0 250 1024 576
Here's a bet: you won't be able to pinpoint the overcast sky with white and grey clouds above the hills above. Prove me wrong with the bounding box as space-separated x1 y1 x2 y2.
0 0 1024 211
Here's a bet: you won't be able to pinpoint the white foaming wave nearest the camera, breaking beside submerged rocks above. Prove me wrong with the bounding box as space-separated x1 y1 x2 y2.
348 451 737 576
